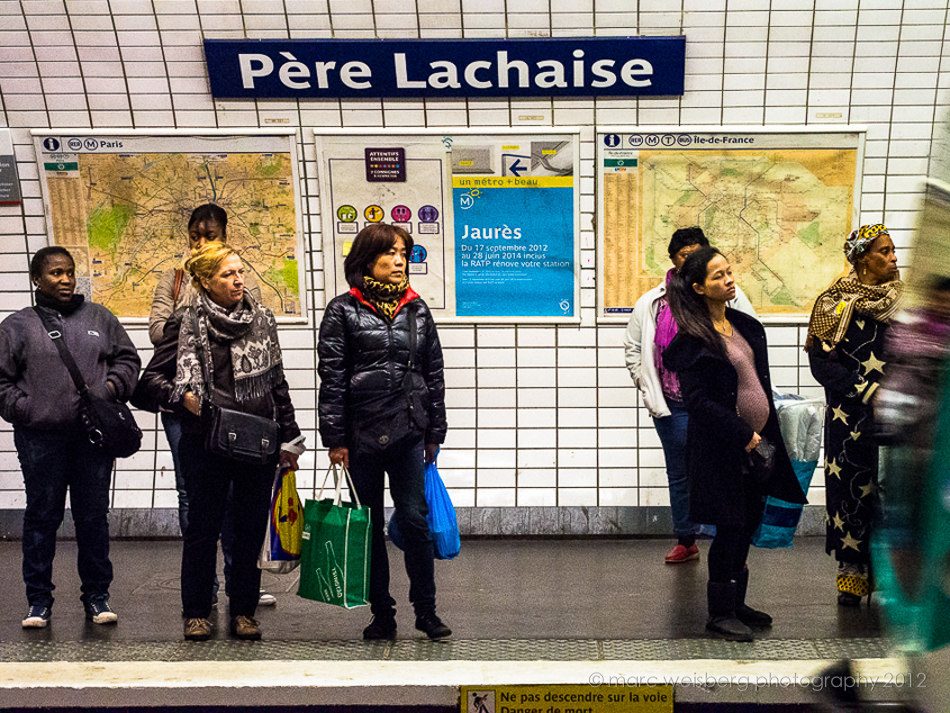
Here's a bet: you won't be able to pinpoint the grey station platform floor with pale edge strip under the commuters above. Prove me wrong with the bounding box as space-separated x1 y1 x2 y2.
0 538 904 710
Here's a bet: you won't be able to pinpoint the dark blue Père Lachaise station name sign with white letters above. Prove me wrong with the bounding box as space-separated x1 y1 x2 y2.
204 36 686 99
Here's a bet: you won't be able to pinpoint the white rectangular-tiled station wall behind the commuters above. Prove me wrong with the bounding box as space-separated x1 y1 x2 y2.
0 0 950 509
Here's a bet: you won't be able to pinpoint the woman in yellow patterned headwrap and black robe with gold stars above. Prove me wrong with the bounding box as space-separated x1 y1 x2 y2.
805 225 904 606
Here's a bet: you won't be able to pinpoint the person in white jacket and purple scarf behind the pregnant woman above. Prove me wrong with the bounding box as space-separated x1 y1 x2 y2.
623 227 755 564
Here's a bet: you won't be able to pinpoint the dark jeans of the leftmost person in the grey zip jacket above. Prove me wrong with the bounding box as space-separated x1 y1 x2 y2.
13 426 114 607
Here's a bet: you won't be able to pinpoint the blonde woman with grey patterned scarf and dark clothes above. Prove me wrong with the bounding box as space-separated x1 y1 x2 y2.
137 242 300 641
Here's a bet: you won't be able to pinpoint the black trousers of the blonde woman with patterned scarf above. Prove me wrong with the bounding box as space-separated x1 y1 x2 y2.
178 433 277 618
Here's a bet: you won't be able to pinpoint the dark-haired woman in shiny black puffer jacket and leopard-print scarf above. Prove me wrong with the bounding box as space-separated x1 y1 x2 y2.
317 224 452 639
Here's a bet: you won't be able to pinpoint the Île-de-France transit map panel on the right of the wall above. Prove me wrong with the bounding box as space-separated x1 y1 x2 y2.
596 127 864 320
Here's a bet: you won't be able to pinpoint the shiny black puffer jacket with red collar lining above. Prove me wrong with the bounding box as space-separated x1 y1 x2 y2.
317 288 447 449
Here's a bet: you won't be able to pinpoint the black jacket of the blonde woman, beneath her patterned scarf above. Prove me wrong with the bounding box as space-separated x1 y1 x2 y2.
132 311 300 443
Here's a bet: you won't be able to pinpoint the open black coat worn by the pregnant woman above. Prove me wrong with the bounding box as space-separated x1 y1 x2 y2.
663 307 806 527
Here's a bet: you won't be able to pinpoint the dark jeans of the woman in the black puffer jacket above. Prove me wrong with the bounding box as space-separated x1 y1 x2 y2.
350 438 435 616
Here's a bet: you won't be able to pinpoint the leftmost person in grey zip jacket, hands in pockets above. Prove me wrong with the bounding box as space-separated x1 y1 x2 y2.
0 246 141 628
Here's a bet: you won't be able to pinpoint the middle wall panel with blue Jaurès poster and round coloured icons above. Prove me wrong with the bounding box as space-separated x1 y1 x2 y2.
314 132 579 322
